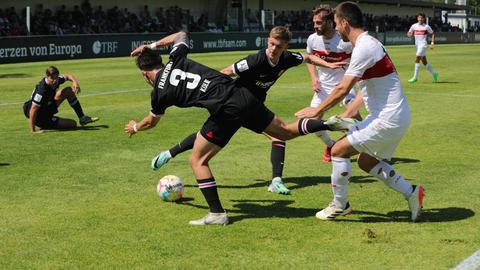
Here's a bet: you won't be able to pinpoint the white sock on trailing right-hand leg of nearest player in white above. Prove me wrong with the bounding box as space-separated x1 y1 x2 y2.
369 161 412 198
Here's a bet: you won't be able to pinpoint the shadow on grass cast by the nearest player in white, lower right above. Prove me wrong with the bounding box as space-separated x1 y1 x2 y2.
336 207 475 223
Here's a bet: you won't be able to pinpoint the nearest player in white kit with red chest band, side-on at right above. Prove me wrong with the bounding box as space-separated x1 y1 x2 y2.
296 2 424 221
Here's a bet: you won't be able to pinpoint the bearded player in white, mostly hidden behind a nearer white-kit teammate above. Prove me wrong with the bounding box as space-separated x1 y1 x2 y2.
307 5 359 162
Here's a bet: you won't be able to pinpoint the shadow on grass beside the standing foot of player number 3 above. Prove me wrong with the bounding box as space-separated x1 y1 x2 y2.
182 200 318 224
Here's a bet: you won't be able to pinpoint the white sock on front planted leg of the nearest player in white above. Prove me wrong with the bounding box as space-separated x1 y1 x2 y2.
331 157 352 209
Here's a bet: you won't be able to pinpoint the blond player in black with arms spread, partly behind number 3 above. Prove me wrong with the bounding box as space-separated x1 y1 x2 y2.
151 26 346 194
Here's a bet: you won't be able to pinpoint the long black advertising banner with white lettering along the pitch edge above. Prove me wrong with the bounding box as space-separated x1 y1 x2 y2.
0 32 480 64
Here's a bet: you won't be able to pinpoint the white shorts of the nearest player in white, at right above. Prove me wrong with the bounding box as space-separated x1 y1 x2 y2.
347 116 409 160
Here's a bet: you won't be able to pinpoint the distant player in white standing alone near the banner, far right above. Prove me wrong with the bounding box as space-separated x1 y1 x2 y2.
407 13 438 83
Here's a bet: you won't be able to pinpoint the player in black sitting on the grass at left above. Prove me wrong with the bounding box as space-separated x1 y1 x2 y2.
23 66 98 133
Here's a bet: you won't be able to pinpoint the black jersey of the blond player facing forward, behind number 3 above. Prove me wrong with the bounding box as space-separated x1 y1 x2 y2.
233 49 304 102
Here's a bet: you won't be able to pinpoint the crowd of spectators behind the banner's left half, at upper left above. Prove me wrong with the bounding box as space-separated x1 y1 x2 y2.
0 0 208 36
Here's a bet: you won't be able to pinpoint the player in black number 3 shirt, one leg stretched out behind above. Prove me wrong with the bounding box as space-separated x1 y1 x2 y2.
124 32 351 225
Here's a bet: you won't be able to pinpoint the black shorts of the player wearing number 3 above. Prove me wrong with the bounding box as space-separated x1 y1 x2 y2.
200 87 275 147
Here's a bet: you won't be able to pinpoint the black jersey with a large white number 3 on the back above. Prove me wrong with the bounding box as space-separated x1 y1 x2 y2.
151 43 235 115
